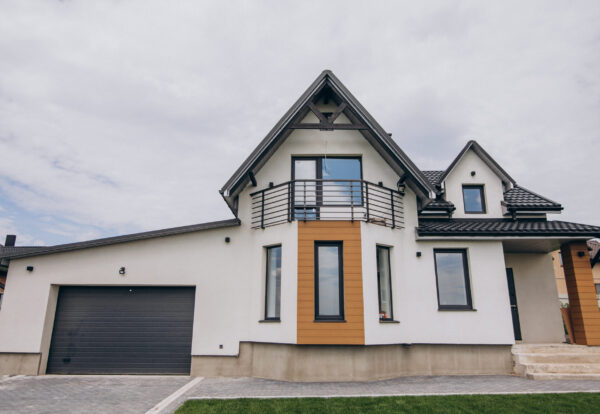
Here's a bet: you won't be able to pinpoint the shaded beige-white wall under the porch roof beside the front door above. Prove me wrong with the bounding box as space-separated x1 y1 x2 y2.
506 253 565 343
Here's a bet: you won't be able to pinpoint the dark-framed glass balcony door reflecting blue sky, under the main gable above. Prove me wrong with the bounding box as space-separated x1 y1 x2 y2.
292 156 362 220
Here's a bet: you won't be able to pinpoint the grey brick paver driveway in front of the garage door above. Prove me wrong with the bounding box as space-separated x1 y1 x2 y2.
0 376 191 414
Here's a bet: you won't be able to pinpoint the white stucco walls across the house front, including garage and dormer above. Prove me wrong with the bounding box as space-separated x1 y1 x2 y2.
0 124 532 355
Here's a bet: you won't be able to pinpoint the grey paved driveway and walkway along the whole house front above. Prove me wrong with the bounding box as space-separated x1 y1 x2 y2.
0 375 600 414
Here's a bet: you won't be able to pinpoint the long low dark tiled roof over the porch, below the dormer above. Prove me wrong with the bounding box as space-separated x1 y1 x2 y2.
417 219 600 238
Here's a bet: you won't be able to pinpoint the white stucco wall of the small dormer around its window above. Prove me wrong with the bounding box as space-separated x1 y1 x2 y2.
445 150 504 219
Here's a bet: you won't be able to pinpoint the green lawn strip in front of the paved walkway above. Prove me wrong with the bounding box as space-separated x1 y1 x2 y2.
175 393 600 414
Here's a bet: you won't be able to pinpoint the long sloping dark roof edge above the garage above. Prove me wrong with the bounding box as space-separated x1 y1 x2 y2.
0 219 241 259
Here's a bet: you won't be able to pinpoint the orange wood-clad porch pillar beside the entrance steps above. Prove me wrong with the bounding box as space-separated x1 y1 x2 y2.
561 242 600 345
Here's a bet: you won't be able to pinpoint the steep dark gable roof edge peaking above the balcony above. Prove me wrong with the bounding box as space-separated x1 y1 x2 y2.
220 70 435 214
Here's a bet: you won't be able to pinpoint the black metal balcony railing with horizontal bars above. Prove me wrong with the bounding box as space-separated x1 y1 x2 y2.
250 180 404 229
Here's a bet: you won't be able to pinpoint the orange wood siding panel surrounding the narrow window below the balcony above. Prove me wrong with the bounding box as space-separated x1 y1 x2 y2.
298 221 365 345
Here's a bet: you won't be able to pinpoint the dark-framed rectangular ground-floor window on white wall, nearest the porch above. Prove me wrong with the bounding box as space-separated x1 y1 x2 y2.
433 249 473 310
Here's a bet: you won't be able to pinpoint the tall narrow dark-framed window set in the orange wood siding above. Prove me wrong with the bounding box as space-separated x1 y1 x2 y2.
315 242 344 320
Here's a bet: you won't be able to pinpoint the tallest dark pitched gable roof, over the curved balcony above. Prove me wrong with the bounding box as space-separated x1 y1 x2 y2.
220 70 435 213
